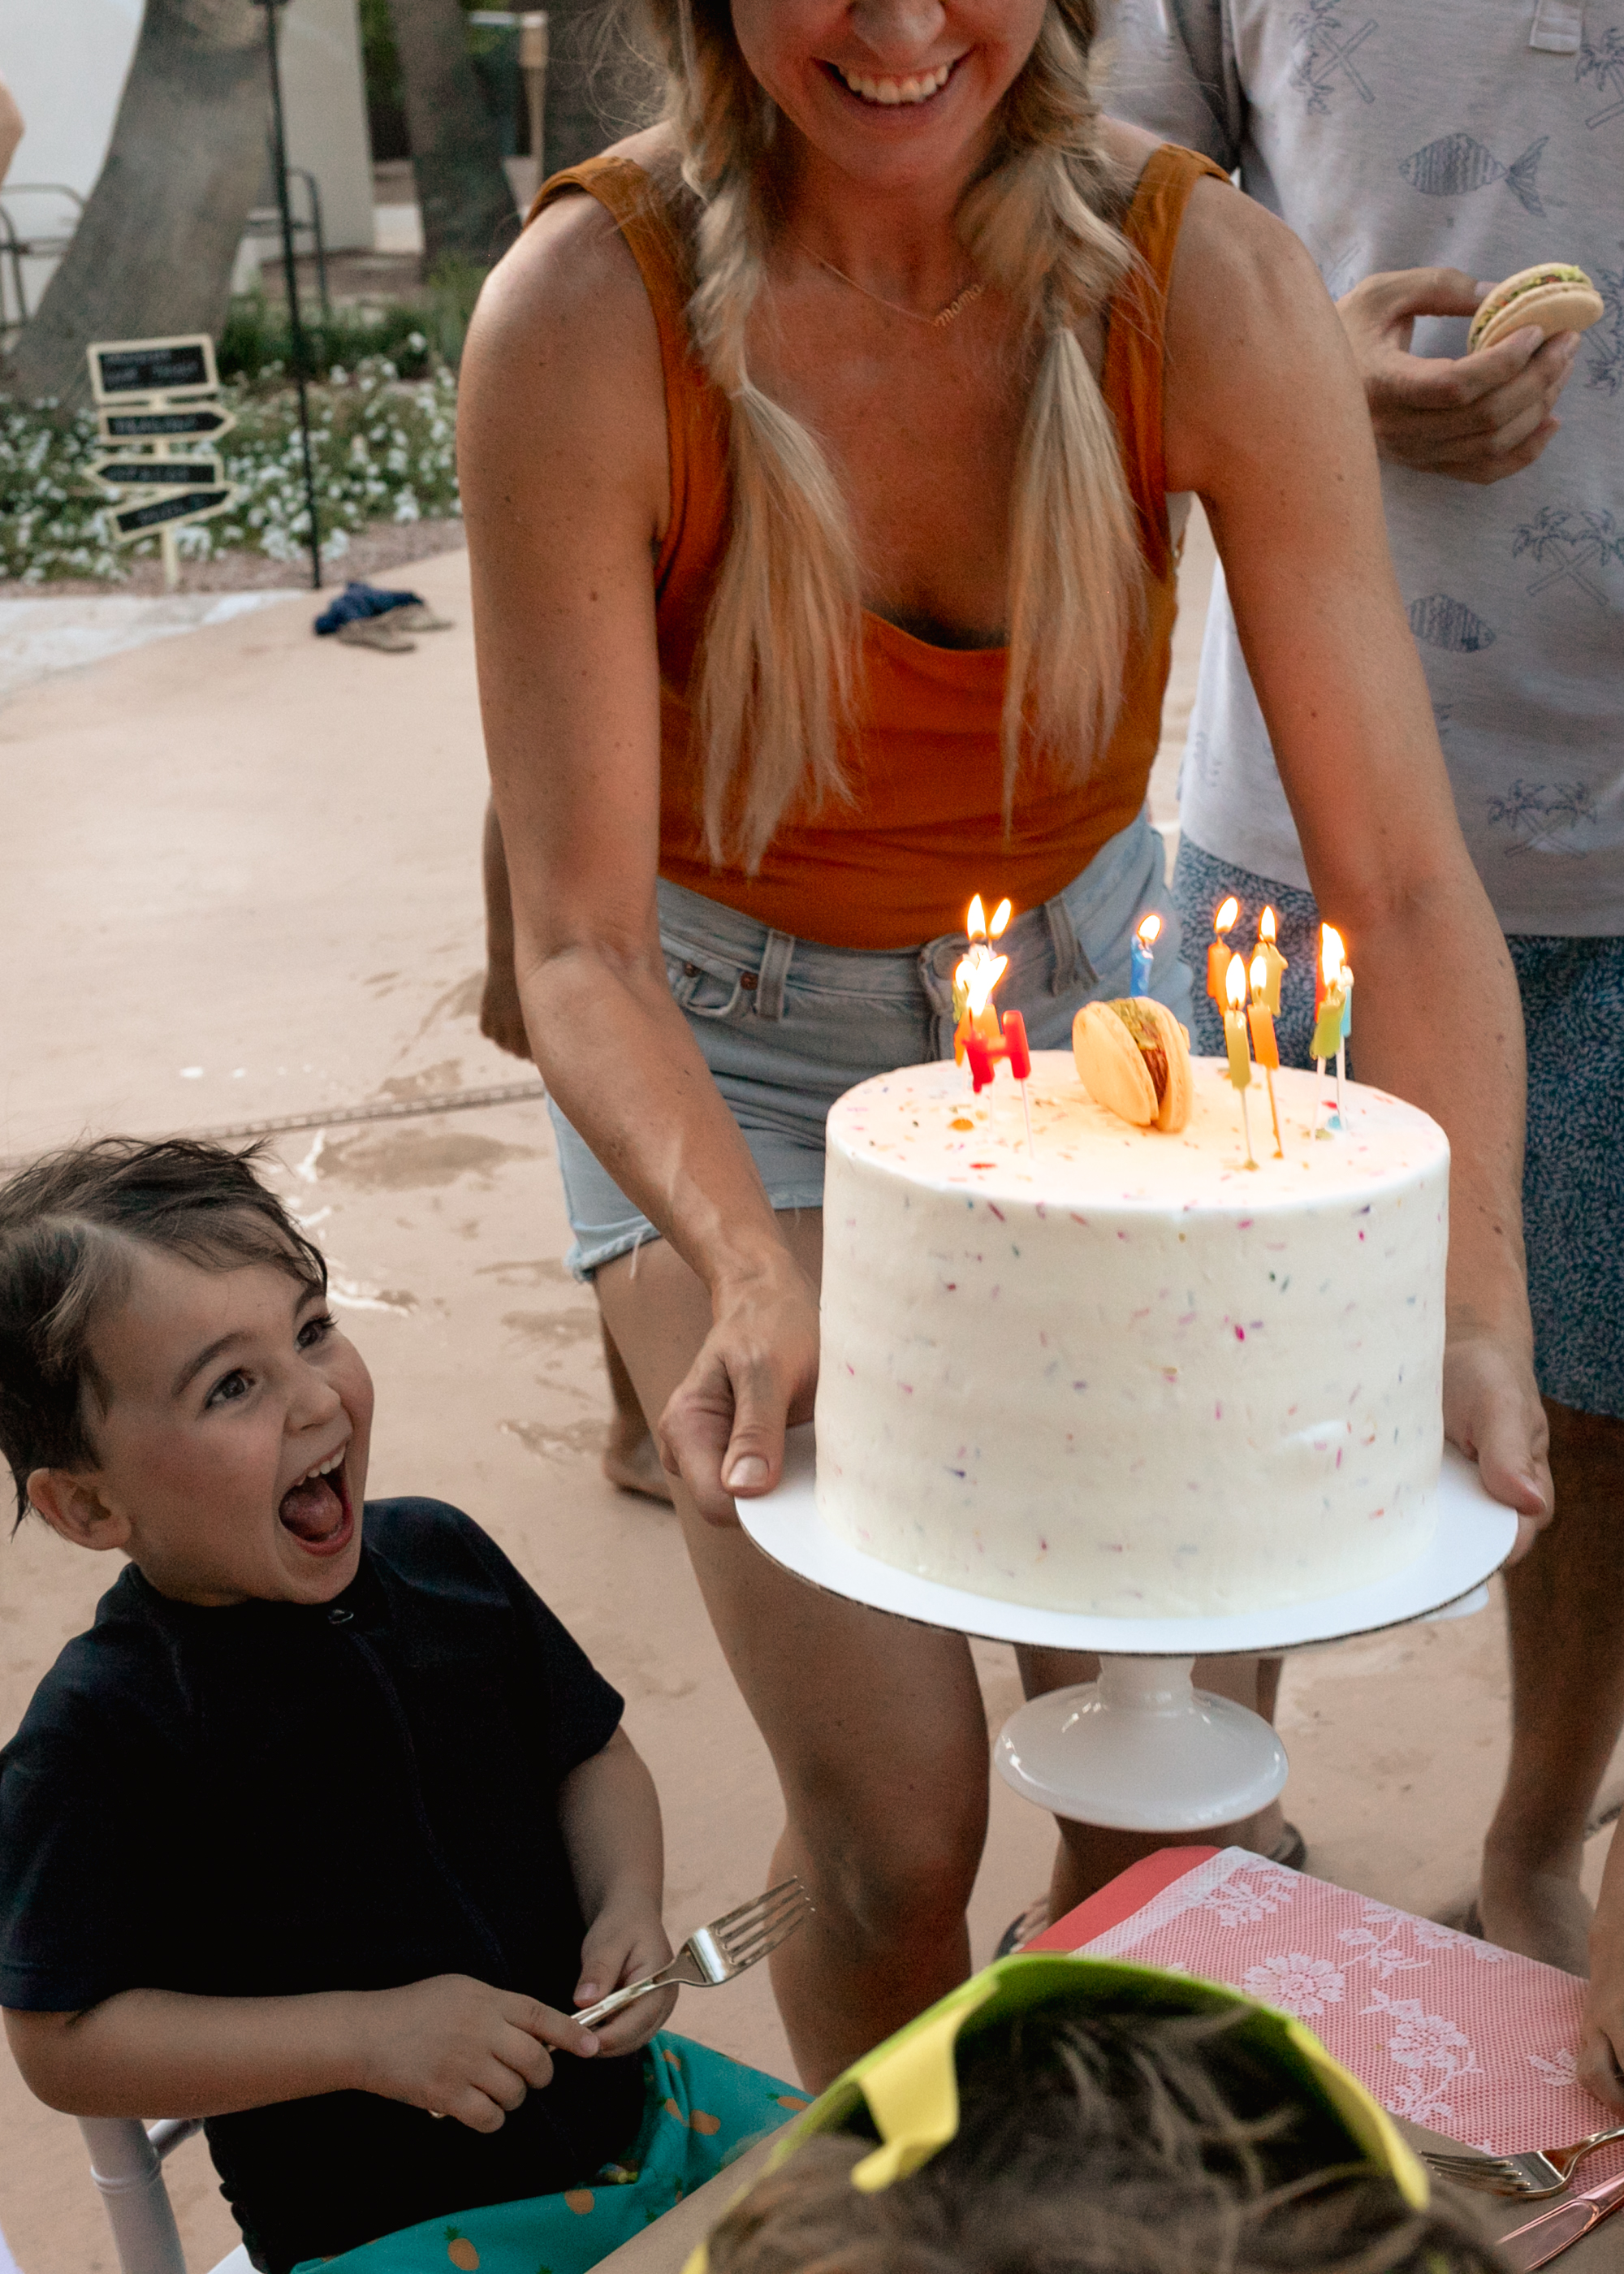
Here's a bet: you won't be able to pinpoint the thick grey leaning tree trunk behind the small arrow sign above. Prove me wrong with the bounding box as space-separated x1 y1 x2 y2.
5 0 269 403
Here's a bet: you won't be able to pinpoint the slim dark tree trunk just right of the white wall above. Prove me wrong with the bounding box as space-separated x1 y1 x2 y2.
389 0 519 268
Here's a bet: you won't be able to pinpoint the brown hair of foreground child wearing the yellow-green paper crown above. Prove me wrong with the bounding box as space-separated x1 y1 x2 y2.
707 2012 1501 2274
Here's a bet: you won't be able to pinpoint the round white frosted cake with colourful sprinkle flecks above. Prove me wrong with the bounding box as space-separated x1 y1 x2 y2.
817 1051 1449 1617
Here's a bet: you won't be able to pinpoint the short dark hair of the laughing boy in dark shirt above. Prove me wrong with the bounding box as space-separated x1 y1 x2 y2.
0 1137 327 1524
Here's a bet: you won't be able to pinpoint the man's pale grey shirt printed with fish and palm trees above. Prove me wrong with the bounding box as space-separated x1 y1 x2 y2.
1105 0 1624 935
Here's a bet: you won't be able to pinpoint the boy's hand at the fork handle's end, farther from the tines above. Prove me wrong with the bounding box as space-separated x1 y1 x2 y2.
357 1974 595 2133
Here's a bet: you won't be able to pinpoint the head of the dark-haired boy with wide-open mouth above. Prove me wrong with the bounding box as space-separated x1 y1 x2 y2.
0 1137 373 1606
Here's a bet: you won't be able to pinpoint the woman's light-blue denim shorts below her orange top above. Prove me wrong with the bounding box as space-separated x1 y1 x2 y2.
548 814 1190 1278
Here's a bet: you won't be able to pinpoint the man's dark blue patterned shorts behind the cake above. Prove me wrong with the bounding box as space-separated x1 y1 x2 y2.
1173 837 1624 1421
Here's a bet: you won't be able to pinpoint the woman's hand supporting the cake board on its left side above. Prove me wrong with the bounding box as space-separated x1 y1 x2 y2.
655 1248 818 1524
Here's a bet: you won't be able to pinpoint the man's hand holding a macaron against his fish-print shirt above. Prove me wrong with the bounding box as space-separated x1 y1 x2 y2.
1337 268 1579 482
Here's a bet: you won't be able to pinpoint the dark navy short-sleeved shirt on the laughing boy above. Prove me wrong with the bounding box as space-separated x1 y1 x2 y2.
0 1501 641 2274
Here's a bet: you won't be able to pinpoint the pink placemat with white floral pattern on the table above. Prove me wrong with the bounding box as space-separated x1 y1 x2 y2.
1044 1848 1624 2155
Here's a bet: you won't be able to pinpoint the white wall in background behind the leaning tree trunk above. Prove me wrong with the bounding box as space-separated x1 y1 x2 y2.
0 0 373 316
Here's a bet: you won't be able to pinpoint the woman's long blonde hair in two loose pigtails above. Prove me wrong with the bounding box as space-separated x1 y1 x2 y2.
648 0 1142 873
